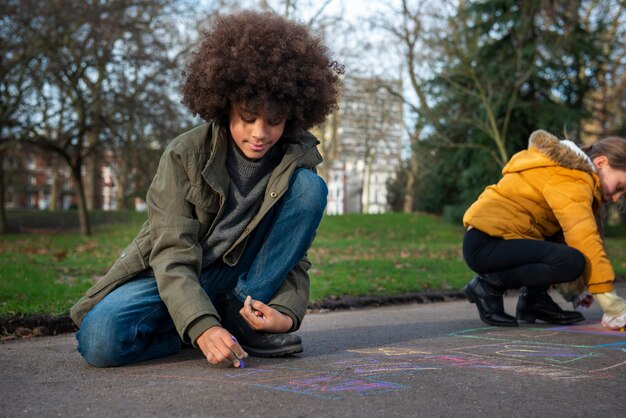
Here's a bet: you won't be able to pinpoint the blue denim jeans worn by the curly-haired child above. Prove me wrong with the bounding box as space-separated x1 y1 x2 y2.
76 169 328 367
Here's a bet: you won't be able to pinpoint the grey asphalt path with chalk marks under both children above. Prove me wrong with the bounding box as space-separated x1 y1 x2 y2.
0 284 626 418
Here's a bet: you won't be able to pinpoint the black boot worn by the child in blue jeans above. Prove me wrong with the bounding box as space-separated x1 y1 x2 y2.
218 297 303 357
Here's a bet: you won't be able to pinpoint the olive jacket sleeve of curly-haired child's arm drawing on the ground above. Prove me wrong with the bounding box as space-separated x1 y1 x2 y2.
146 146 220 344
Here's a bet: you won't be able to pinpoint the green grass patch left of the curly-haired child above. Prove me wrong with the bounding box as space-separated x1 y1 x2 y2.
0 211 146 315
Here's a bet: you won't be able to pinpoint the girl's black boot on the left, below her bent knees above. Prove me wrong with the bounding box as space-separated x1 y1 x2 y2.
463 275 518 327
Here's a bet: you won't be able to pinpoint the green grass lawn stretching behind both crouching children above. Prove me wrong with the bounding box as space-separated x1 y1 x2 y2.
0 211 626 316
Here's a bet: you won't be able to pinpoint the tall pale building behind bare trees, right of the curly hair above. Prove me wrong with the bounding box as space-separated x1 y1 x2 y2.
326 77 403 215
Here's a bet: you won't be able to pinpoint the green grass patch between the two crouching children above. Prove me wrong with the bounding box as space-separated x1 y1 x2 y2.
309 213 471 301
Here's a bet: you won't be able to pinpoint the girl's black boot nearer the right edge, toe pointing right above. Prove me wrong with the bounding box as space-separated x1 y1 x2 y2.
515 288 585 325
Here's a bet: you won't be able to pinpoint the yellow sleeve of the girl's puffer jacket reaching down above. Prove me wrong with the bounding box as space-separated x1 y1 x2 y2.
543 174 615 293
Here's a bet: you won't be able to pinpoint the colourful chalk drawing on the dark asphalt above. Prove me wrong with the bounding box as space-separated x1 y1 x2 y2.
125 326 626 400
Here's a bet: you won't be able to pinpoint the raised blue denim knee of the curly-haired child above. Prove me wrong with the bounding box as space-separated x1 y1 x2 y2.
285 168 328 214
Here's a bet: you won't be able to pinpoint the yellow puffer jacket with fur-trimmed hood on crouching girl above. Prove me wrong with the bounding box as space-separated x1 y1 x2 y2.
463 130 615 293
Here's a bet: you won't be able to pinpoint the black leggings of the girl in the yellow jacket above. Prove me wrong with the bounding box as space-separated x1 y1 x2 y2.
463 228 585 288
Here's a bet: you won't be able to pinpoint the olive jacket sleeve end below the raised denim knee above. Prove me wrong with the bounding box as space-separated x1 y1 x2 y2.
268 256 311 332
